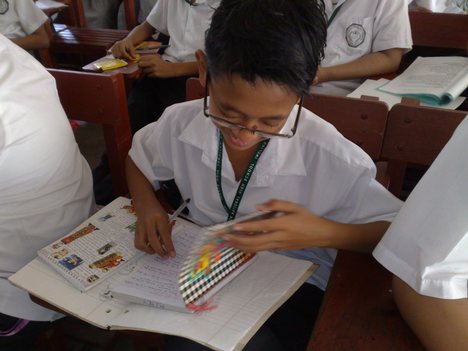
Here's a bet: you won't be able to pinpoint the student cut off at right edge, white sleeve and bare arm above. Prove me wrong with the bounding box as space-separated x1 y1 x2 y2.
374 118 468 351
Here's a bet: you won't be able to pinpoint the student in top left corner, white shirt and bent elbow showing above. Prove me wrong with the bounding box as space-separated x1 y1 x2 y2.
0 0 49 50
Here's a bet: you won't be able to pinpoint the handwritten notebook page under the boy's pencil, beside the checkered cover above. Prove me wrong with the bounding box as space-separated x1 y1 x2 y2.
112 218 201 311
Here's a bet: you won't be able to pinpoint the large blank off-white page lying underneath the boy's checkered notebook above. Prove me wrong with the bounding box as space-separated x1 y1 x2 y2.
112 252 316 350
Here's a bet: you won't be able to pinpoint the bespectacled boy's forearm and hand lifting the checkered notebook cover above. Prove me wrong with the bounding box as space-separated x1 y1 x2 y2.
222 200 390 252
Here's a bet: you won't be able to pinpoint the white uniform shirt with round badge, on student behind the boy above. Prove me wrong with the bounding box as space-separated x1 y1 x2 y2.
312 0 413 95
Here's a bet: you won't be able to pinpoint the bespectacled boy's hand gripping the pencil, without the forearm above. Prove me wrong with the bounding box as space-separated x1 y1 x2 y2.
135 206 175 257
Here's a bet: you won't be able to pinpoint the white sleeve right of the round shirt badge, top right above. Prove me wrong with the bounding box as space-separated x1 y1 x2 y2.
372 0 413 52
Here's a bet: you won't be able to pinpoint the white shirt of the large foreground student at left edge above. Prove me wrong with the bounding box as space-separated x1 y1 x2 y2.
0 35 94 321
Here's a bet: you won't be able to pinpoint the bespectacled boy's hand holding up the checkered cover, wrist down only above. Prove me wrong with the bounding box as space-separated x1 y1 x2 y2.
218 200 334 252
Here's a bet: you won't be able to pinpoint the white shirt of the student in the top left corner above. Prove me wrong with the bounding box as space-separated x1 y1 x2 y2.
0 0 48 39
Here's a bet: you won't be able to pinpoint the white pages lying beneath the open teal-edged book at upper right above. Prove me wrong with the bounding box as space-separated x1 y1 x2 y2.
347 78 465 110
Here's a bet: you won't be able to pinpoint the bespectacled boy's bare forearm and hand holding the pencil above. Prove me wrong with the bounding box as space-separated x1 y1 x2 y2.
125 156 175 257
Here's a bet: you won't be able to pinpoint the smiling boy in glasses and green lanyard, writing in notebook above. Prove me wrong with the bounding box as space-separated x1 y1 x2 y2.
127 0 401 350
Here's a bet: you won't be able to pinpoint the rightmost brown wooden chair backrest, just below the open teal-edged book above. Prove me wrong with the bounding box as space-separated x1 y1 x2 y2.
382 104 467 196
